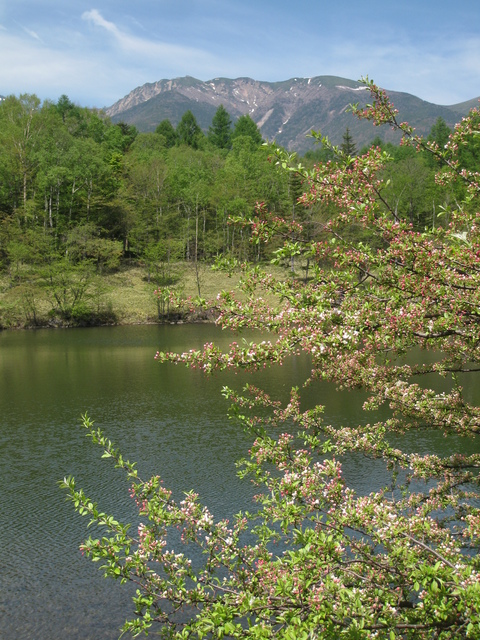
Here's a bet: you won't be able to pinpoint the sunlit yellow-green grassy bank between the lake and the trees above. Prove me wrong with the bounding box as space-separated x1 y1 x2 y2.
0 263 284 329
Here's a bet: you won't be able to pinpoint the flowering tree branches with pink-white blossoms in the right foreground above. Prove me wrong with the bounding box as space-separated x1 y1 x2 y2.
64 80 480 640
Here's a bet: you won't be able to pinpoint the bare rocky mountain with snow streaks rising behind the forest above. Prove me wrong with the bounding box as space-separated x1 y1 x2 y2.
106 76 477 153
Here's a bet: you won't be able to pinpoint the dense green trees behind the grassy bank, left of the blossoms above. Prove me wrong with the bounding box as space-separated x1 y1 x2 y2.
0 95 289 268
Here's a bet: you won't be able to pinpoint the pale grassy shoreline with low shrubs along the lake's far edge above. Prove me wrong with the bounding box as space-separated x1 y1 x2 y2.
0 264 285 331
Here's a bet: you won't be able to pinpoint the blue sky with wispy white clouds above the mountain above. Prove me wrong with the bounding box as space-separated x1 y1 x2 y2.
0 0 480 107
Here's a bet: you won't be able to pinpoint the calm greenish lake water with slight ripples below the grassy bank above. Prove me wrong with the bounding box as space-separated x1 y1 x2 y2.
0 325 480 640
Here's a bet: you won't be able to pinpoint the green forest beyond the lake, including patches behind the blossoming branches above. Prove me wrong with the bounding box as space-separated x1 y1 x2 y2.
0 94 480 328
